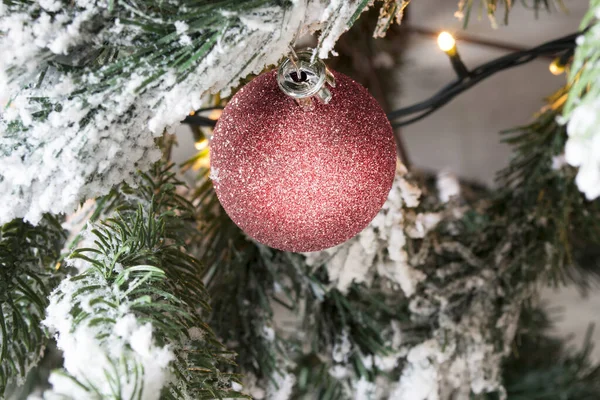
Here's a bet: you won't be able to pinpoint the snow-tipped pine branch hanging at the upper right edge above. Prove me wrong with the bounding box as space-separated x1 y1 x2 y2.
564 0 600 200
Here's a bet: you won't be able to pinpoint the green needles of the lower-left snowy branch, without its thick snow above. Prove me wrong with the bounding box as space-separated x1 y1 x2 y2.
44 163 245 399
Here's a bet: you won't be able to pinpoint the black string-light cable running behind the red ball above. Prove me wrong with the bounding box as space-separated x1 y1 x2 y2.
182 32 581 128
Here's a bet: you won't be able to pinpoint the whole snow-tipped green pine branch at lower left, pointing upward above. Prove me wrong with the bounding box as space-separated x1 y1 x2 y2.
43 163 239 400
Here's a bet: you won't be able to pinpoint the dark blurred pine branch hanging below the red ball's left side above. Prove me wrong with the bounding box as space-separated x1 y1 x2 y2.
192 166 298 380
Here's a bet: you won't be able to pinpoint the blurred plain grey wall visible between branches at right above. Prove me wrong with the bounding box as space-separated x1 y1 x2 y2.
393 0 600 360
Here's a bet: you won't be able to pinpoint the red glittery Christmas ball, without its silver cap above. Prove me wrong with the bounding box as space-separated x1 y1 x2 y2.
211 62 396 252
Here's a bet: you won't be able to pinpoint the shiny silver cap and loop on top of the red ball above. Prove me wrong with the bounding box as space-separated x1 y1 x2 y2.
277 49 335 109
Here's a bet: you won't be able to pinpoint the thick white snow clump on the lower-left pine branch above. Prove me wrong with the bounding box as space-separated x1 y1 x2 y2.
42 216 192 400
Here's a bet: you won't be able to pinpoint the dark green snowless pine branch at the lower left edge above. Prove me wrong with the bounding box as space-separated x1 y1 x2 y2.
0 216 65 397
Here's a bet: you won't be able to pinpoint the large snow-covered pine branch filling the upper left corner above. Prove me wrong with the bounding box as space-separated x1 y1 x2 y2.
0 0 369 224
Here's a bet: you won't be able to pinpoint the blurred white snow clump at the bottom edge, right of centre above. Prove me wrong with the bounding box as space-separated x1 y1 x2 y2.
389 291 519 400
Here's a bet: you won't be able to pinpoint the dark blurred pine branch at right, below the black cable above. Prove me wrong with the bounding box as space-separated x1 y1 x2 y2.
491 89 600 288
